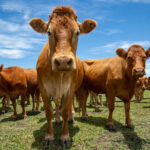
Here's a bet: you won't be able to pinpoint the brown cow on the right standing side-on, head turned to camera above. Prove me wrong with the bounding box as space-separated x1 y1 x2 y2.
77 45 150 130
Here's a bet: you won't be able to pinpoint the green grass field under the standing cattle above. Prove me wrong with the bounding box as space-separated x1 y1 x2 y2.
0 91 150 150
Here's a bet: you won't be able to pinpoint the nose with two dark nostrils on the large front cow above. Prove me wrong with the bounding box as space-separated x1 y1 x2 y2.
54 56 73 71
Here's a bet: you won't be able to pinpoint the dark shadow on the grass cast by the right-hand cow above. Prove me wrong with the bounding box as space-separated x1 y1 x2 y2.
75 116 150 150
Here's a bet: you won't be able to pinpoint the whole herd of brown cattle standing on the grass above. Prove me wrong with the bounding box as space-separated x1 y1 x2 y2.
0 6 150 148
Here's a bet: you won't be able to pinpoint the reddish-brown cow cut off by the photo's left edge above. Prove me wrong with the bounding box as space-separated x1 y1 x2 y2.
0 65 27 118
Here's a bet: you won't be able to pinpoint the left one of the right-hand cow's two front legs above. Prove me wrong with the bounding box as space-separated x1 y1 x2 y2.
107 92 115 131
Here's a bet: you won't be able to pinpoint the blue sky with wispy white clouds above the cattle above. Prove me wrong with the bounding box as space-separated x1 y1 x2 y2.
0 0 150 75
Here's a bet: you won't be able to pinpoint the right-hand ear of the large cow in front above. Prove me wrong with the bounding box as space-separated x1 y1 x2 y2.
79 19 97 34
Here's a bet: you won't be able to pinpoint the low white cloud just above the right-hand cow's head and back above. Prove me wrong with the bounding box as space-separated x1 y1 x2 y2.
89 41 150 54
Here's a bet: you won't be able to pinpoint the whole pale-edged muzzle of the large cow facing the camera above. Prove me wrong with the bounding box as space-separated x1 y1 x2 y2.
52 56 76 71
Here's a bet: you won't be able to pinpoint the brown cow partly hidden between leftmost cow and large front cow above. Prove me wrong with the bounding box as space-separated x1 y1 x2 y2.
24 69 40 111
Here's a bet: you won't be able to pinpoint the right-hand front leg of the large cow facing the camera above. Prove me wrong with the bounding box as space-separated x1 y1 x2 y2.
61 95 73 148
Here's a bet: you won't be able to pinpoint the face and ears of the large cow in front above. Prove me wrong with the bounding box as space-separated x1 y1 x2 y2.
29 6 97 71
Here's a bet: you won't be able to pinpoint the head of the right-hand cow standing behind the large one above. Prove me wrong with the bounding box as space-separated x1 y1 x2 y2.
116 45 150 77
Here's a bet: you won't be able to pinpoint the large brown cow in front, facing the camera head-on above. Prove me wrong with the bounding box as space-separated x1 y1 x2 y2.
29 6 96 147
